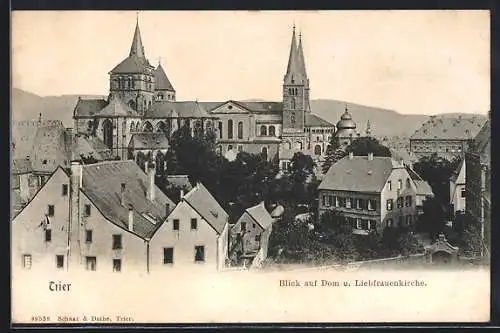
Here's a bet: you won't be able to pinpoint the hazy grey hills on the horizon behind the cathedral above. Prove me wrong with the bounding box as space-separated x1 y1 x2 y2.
12 88 486 136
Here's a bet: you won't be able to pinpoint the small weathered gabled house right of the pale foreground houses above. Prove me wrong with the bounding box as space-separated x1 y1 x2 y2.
231 201 273 255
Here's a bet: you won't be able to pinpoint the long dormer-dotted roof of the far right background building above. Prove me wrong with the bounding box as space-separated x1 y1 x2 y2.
410 116 485 140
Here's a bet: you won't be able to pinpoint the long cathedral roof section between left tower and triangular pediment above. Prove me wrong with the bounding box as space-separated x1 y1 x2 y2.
144 101 213 118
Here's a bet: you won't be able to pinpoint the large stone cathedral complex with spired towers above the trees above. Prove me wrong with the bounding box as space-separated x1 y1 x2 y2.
73 17 368 169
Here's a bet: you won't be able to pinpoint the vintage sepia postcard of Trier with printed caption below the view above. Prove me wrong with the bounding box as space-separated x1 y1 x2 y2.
10 10 491 326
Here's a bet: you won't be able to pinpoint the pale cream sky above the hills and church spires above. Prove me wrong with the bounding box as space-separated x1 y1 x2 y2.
12 10 490 114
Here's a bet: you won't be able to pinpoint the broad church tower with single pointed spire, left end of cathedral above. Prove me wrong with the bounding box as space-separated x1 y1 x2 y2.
109 20 155 115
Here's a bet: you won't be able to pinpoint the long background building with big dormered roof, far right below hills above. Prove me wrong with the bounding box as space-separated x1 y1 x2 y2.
410 115 485 160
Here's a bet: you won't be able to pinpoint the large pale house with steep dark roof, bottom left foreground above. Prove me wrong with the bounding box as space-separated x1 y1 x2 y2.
12 161 174 272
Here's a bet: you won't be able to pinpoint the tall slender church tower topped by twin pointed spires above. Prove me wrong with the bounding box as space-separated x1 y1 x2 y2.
283 26 311 136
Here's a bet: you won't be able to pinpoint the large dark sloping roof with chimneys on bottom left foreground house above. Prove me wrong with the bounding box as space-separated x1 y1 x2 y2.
82 160 175 239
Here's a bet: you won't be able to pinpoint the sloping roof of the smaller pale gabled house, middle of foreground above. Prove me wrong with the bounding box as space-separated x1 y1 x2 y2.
182 183 228 234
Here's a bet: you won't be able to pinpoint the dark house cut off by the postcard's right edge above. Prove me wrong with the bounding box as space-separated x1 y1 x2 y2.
465 116 492 254
